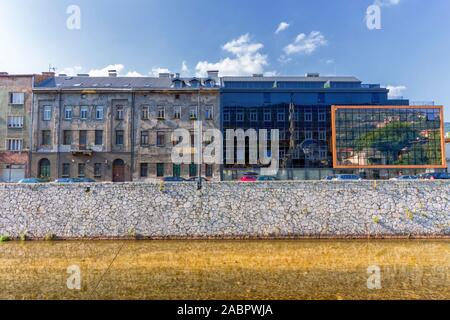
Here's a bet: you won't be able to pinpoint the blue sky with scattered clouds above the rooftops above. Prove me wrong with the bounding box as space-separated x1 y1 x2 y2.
0 0 450 120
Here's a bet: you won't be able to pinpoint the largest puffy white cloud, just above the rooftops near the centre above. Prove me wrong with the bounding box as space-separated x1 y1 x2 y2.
195 33 268 77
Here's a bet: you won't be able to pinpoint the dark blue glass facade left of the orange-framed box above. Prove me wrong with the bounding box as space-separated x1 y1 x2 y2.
221 78 409 175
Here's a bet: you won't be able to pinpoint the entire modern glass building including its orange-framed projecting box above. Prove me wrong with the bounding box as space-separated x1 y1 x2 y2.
221 74 443 180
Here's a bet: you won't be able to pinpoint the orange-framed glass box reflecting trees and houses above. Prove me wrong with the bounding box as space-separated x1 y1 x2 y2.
331 106 447 174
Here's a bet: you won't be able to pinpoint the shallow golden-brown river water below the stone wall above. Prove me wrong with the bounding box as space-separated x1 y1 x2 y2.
0 240 450 299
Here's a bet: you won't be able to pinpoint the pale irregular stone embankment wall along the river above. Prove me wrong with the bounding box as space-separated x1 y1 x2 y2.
0 181 450 238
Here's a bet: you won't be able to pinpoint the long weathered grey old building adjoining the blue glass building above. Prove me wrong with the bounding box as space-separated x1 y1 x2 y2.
31 72 220 182
